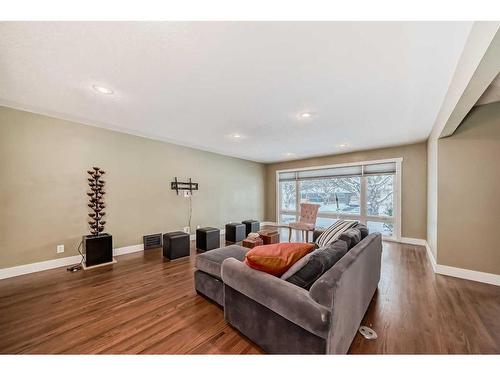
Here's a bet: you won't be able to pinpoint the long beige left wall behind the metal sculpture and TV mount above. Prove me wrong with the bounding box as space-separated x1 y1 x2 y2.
0 107 265 268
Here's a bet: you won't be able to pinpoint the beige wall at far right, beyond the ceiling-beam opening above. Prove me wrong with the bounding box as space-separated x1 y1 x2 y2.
437 102 500 274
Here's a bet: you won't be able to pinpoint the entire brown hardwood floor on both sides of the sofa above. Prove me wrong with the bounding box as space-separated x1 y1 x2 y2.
0 236 500 354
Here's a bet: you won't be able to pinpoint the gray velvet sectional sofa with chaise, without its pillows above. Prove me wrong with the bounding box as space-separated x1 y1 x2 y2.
195 228 382 354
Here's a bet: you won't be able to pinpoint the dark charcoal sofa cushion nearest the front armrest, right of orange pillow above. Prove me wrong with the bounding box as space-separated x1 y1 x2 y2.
286 240 348 290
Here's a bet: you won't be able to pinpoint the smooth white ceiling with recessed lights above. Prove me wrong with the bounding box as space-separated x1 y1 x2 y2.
0 22 472 162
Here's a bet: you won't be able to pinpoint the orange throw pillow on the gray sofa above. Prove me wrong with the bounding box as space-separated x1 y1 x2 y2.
245 242 315 276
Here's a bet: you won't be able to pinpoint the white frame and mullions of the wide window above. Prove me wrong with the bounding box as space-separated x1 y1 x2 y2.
276 158 403 241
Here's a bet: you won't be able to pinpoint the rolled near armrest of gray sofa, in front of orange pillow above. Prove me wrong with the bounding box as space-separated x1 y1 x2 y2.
222 258 330 338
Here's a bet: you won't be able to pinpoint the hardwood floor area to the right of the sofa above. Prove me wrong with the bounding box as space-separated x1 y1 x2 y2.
350 242 500 354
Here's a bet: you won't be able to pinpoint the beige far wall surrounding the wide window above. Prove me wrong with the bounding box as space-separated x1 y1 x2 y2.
265 142 427 239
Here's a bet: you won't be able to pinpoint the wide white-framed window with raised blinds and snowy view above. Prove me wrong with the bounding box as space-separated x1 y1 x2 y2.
277 159 401 238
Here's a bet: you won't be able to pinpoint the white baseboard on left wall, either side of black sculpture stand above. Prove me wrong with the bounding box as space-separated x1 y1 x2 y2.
0 244 144 280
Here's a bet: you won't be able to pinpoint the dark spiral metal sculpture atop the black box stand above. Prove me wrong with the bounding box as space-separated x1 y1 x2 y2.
87 167 106 235
